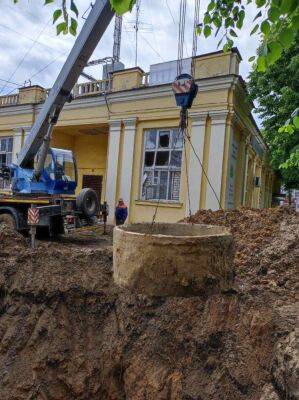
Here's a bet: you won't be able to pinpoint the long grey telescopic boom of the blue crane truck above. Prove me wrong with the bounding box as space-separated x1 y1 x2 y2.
17 0 114 168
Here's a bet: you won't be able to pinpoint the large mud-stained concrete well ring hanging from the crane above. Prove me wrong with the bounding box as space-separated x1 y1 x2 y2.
113 223 234 296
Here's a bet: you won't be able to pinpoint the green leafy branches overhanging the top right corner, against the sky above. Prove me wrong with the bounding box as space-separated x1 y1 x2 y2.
200 0 299 71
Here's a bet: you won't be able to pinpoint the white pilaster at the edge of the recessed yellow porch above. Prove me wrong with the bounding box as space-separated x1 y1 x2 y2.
106 121 121 224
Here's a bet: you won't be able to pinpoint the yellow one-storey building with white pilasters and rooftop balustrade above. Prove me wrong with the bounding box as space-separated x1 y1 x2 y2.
0 49 273 222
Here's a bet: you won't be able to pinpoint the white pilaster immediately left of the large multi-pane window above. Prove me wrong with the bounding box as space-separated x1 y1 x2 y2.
120 118 136 214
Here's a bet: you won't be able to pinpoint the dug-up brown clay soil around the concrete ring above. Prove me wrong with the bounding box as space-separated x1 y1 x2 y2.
0 209 299 400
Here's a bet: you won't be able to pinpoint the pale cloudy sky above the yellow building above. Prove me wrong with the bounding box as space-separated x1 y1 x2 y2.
0 0 258 95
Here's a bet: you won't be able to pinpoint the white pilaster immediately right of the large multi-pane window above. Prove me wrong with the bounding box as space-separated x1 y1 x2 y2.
186 112 207 215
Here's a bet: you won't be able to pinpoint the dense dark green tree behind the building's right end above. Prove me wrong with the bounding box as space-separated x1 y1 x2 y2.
248 34 299 188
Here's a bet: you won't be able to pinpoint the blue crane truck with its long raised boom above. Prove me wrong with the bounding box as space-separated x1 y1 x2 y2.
0 0 114 235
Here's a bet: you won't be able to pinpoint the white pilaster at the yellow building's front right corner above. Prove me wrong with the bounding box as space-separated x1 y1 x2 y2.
206 110 227 210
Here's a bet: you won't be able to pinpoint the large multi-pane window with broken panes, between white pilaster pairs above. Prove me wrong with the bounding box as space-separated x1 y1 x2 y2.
141 129 183 202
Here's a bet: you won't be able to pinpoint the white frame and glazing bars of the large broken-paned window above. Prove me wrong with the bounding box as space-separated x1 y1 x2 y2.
139 127 184 204
